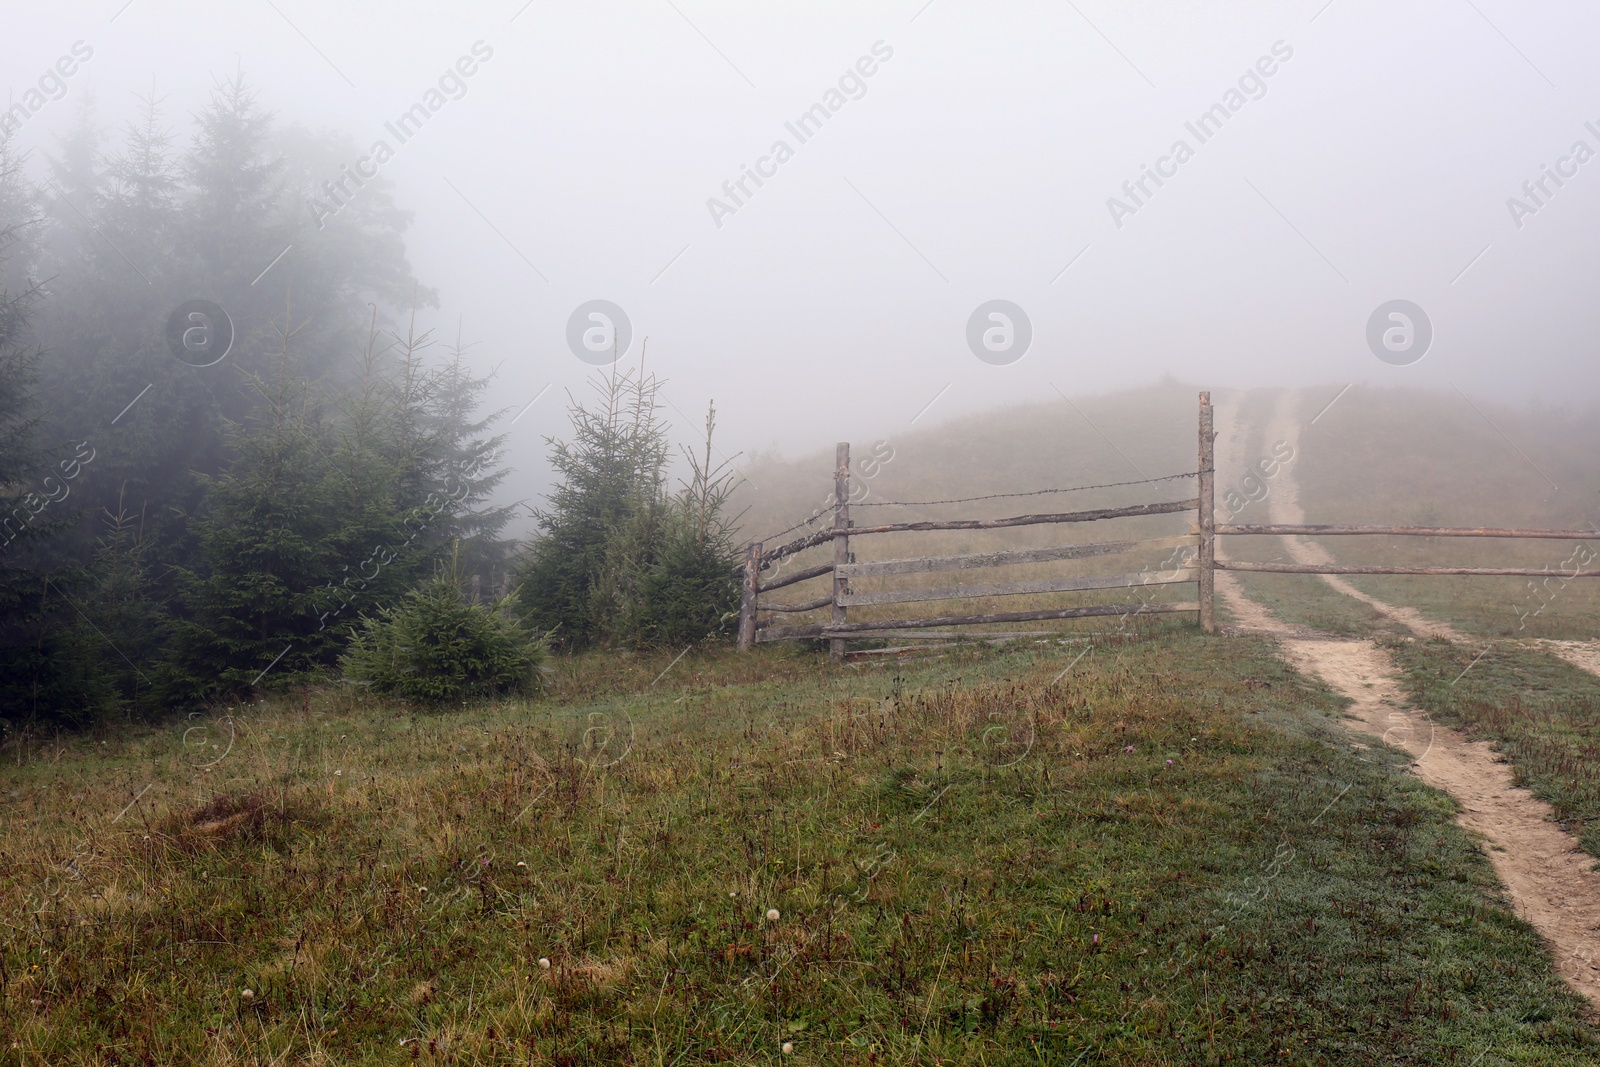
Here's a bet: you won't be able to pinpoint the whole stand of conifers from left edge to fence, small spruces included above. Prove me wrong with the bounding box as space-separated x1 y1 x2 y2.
0 77 738 726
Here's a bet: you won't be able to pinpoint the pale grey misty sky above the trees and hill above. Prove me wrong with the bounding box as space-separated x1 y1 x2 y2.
0 0 1600 518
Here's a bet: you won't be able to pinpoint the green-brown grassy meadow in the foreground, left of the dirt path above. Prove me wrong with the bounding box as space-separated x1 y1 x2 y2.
0 625 1600 1065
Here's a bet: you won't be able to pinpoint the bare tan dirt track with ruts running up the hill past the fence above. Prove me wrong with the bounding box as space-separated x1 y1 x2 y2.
1216 392 1600 1008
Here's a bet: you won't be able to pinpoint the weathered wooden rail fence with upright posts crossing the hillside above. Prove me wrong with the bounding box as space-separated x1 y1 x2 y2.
739 392 1600 661
